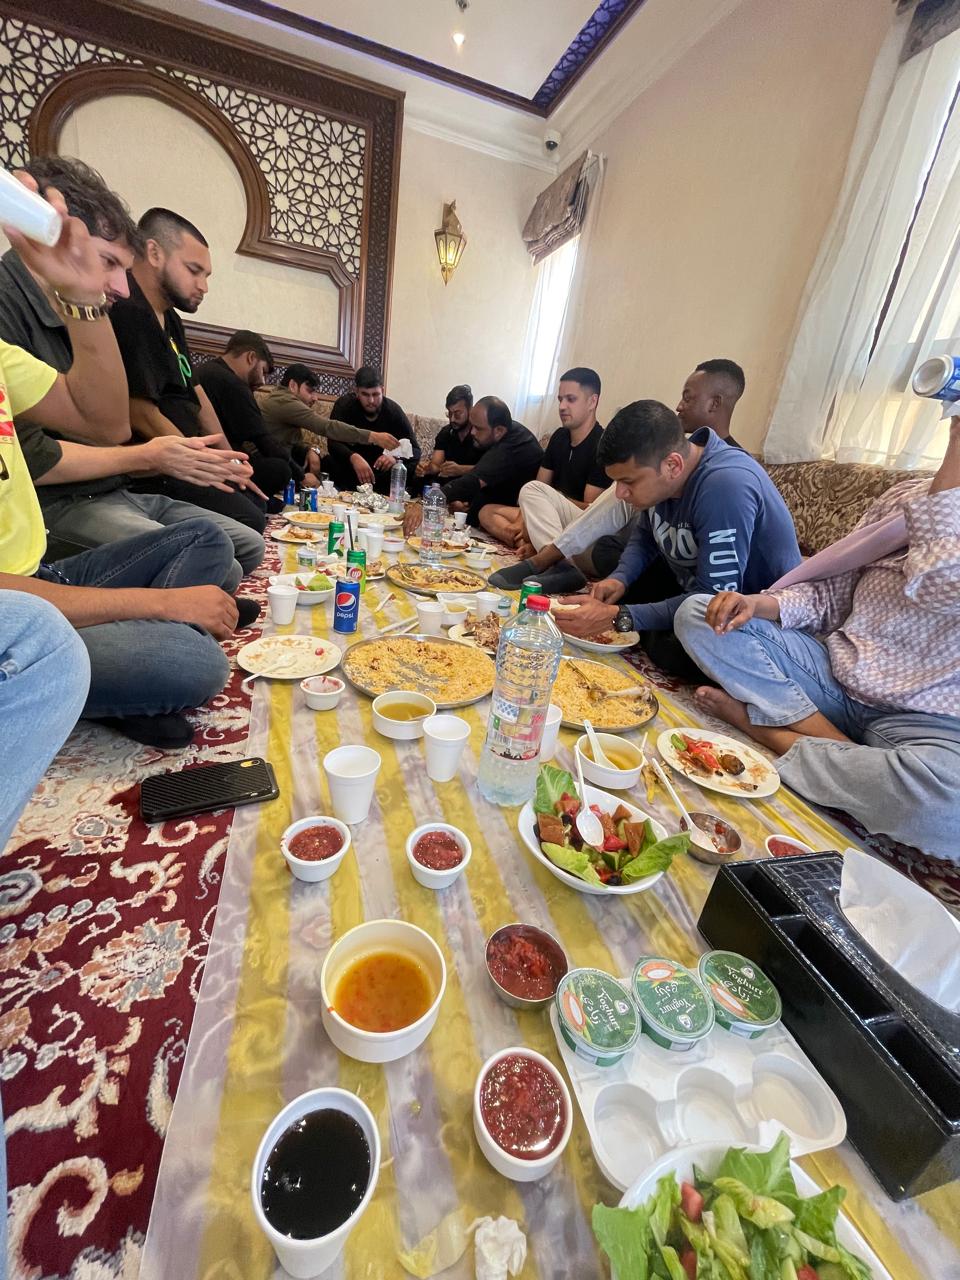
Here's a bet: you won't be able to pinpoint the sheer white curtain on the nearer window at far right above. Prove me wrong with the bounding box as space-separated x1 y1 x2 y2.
764 19 960 467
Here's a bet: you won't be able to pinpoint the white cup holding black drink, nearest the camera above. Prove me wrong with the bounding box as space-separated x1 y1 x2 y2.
250 1089 380 1280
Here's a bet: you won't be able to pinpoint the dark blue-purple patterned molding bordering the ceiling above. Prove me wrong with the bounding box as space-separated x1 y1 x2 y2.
208 0 646 119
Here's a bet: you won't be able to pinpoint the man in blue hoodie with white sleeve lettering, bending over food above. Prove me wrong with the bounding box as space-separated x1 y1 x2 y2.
557 401 800 677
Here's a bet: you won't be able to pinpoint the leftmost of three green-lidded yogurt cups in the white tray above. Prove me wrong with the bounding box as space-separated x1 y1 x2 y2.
554 969 640 1066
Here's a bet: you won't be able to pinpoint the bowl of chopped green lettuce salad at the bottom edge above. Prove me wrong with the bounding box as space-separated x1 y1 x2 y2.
593 1134 892 1280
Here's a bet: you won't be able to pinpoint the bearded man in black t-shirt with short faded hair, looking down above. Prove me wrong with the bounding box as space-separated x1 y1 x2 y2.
110 209 273 532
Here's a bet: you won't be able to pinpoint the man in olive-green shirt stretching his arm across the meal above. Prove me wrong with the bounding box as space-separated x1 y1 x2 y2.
255 365 399 484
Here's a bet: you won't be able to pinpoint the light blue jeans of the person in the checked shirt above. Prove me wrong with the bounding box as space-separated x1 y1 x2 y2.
673 595 960 861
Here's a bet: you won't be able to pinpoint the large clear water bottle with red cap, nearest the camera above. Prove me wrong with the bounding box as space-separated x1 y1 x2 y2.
477 595 563 805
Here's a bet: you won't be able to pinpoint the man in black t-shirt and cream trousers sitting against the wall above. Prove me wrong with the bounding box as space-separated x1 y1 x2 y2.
480 369 611 557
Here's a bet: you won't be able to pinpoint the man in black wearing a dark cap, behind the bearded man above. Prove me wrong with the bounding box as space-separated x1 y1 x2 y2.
196 329 296 493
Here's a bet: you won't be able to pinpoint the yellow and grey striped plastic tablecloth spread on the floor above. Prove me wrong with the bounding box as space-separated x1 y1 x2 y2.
141 554 960 1280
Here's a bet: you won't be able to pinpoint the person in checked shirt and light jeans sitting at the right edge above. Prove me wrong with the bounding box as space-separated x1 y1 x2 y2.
675 417 960 861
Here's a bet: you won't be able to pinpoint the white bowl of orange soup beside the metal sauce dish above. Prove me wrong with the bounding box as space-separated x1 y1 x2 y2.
320 920 447 1062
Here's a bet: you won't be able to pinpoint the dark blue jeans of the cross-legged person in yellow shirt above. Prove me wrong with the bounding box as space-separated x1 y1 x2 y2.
47 520 233 719
